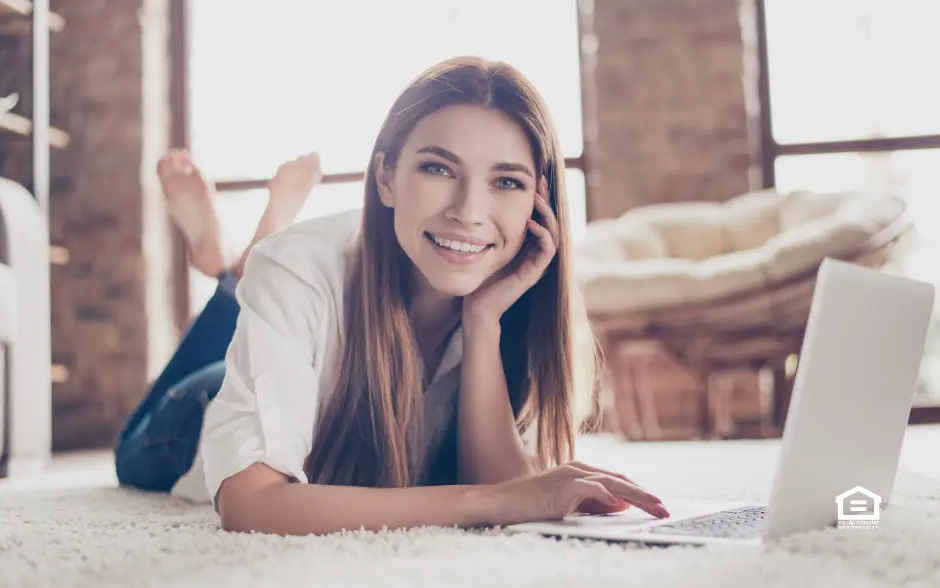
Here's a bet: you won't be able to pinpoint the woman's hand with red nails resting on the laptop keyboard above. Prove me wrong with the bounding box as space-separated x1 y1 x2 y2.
485 462 669 526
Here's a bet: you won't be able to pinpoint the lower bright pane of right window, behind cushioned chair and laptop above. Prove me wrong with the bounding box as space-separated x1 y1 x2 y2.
776 149 940 404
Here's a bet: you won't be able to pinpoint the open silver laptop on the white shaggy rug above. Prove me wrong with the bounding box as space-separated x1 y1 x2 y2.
507 259 934 545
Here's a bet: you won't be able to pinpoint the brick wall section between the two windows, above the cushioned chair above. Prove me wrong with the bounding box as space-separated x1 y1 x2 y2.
581 0 760 218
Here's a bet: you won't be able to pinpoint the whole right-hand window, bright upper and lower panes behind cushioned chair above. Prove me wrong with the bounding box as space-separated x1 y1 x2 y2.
759 0 940 414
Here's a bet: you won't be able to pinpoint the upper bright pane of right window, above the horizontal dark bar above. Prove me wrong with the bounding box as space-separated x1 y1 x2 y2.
766 0 940 143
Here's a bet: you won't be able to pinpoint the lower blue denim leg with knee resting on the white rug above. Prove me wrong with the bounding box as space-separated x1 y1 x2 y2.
115 360 225 492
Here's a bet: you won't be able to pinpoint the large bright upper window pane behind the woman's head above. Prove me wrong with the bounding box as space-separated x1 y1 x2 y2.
189 0 583 179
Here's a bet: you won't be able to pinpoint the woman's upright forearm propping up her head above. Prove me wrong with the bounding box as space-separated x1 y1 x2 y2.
457 321 534 484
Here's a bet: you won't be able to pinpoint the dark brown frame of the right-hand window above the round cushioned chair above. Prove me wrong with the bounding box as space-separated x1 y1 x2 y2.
755 0 940 424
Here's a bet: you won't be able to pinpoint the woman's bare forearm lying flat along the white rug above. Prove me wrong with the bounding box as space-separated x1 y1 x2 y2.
222 483 495 535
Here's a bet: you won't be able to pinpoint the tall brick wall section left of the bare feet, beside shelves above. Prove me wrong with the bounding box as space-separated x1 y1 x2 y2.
50 0 173 449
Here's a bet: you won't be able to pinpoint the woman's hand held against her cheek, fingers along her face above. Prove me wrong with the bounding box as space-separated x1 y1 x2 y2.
463 177 558 322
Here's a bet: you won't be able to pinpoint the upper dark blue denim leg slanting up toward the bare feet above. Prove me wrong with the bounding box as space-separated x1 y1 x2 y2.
119 274 239 443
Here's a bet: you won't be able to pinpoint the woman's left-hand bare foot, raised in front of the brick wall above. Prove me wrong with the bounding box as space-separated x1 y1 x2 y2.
157 150 226 277
